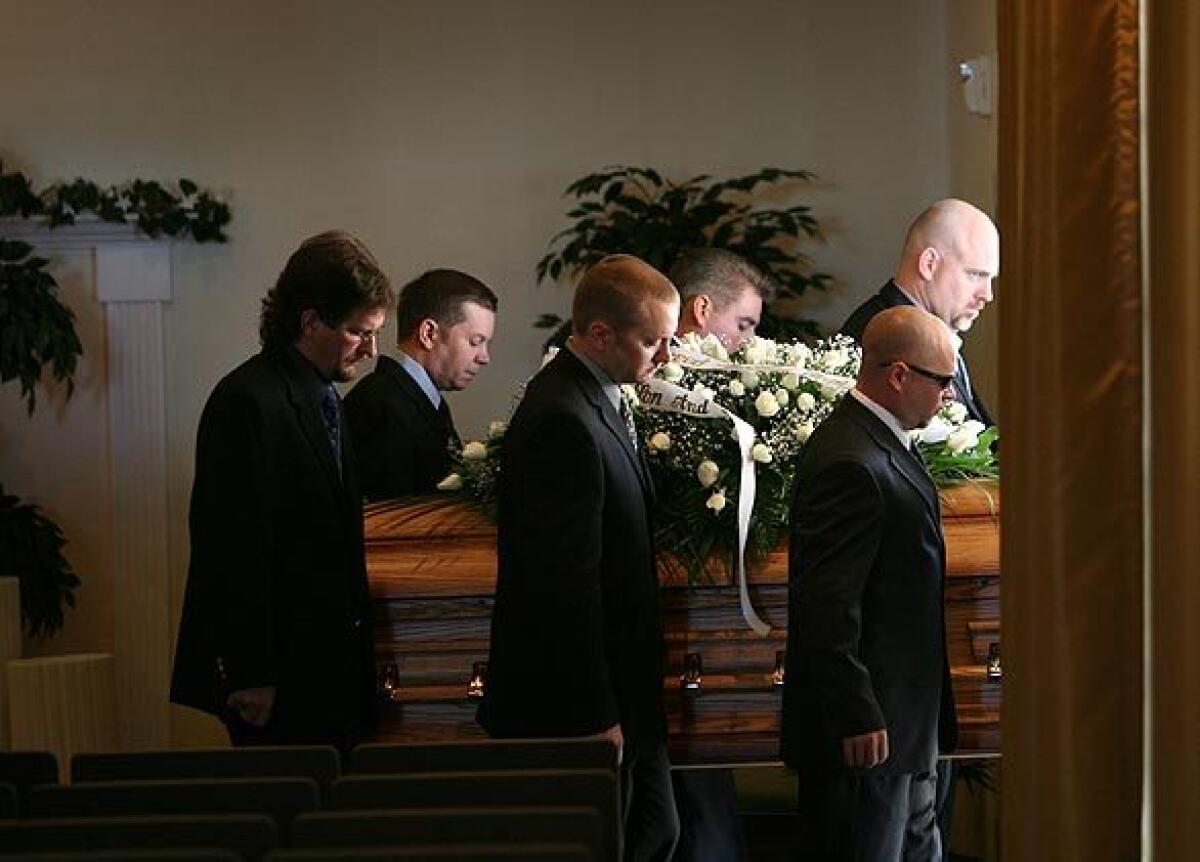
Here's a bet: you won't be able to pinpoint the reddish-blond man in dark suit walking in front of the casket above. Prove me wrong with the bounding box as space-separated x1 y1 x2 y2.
479 255 679 862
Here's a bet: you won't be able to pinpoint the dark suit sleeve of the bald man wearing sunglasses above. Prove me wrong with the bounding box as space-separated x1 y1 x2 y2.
791 461 886 738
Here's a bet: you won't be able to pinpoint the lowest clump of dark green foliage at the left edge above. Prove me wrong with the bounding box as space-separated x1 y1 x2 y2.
0 485 79 637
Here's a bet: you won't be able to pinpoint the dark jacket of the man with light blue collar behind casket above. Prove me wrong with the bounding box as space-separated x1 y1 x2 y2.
346 355 458 501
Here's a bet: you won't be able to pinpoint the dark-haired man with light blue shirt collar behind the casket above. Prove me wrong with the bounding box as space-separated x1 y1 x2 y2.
346 269 499 501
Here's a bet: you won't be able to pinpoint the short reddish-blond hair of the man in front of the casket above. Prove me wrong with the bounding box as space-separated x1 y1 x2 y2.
571 255 679 335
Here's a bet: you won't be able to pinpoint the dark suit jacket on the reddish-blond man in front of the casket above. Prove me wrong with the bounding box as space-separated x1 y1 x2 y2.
479 349 666 753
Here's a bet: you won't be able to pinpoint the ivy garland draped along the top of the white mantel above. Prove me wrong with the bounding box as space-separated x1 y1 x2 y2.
0 162 232 243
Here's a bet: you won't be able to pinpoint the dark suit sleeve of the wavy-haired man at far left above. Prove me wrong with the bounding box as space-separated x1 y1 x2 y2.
192 393 278 690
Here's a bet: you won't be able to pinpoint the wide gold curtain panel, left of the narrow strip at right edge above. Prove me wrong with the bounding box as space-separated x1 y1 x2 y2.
997 0 1142 862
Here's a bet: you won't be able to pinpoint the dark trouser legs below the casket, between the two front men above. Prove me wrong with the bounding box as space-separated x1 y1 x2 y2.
671 770 746 862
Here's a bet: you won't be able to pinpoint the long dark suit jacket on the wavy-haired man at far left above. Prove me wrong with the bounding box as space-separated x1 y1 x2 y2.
170 348 374 743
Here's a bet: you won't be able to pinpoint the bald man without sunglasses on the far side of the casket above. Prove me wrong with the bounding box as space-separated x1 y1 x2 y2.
841 198 1000 425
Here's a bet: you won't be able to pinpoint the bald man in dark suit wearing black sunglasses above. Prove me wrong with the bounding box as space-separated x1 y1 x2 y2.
782 306 956 862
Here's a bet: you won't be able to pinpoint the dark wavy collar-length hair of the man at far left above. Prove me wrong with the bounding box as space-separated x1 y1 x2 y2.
258 231 395 347
